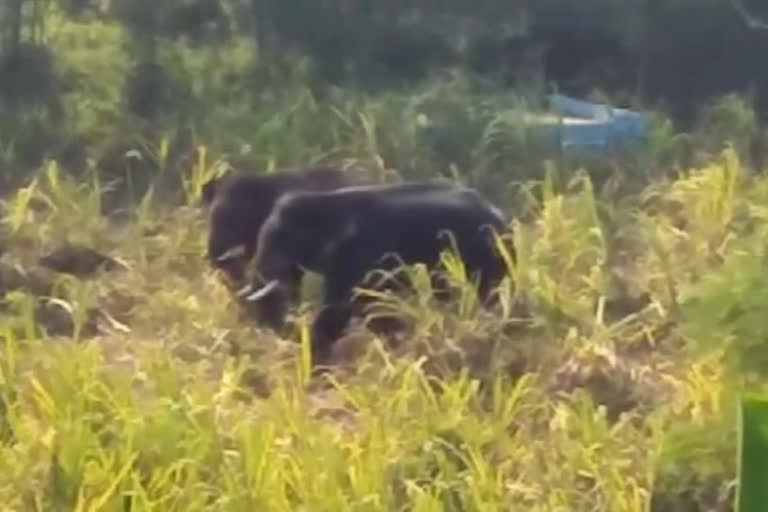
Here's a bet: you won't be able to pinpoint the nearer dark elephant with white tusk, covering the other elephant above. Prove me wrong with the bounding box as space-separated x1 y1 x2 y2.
248 182 514 360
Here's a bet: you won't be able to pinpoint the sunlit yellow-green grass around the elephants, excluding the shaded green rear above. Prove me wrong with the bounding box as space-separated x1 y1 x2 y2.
0 119 768 512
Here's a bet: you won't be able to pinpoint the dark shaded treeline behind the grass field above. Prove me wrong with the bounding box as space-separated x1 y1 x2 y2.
0 0 768 189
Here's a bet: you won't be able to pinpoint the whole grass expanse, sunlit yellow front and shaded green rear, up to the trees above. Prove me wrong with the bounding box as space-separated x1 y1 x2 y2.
0 13 768 512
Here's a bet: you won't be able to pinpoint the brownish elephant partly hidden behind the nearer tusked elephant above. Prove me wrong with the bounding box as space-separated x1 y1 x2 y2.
201 165 368 317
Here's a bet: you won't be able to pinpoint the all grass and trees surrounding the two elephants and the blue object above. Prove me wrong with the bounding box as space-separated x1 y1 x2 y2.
0 0 768 512
